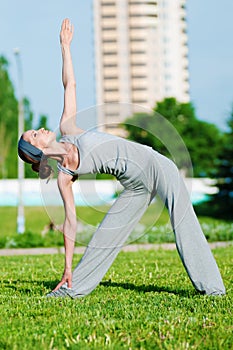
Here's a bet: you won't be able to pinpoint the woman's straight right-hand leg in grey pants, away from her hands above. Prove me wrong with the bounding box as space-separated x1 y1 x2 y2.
153 156 225 295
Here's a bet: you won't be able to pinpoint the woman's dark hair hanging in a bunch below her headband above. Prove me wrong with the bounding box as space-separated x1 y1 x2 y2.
18 144 53 179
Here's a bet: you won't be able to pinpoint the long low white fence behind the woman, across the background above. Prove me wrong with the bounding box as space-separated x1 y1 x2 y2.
0 178 217 206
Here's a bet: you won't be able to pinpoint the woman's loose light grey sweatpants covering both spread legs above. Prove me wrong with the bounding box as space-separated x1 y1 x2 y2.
48 152 225 298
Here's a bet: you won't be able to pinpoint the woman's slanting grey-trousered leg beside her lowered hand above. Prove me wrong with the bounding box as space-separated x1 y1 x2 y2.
48 189 151 298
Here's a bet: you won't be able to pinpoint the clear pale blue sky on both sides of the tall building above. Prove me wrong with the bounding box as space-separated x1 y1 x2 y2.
0 0 233 128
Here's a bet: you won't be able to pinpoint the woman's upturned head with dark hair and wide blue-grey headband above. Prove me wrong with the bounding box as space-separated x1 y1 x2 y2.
18 128 54 179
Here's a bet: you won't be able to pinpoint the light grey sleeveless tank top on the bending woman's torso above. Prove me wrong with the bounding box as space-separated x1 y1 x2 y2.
57 131 153 187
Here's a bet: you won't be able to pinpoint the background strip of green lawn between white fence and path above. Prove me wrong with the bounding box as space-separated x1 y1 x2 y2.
0 203 233 248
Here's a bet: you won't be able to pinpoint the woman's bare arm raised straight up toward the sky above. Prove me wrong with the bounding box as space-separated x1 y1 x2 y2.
60 19 83 135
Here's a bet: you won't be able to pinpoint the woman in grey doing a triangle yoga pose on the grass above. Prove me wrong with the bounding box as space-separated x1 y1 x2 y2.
18 19 225 298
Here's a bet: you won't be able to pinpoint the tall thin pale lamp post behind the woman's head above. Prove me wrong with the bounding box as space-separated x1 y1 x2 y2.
14 48 25 233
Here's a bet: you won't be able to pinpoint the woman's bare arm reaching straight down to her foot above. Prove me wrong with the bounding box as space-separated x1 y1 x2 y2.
54 172 77 290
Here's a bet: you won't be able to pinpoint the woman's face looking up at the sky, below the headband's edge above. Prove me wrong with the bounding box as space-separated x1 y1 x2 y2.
23 128 56 150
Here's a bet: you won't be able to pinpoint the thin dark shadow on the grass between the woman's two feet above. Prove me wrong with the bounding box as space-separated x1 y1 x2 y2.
100 281 194 297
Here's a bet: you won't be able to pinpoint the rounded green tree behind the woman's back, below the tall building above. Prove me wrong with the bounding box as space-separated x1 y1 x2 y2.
124 98 222 176
